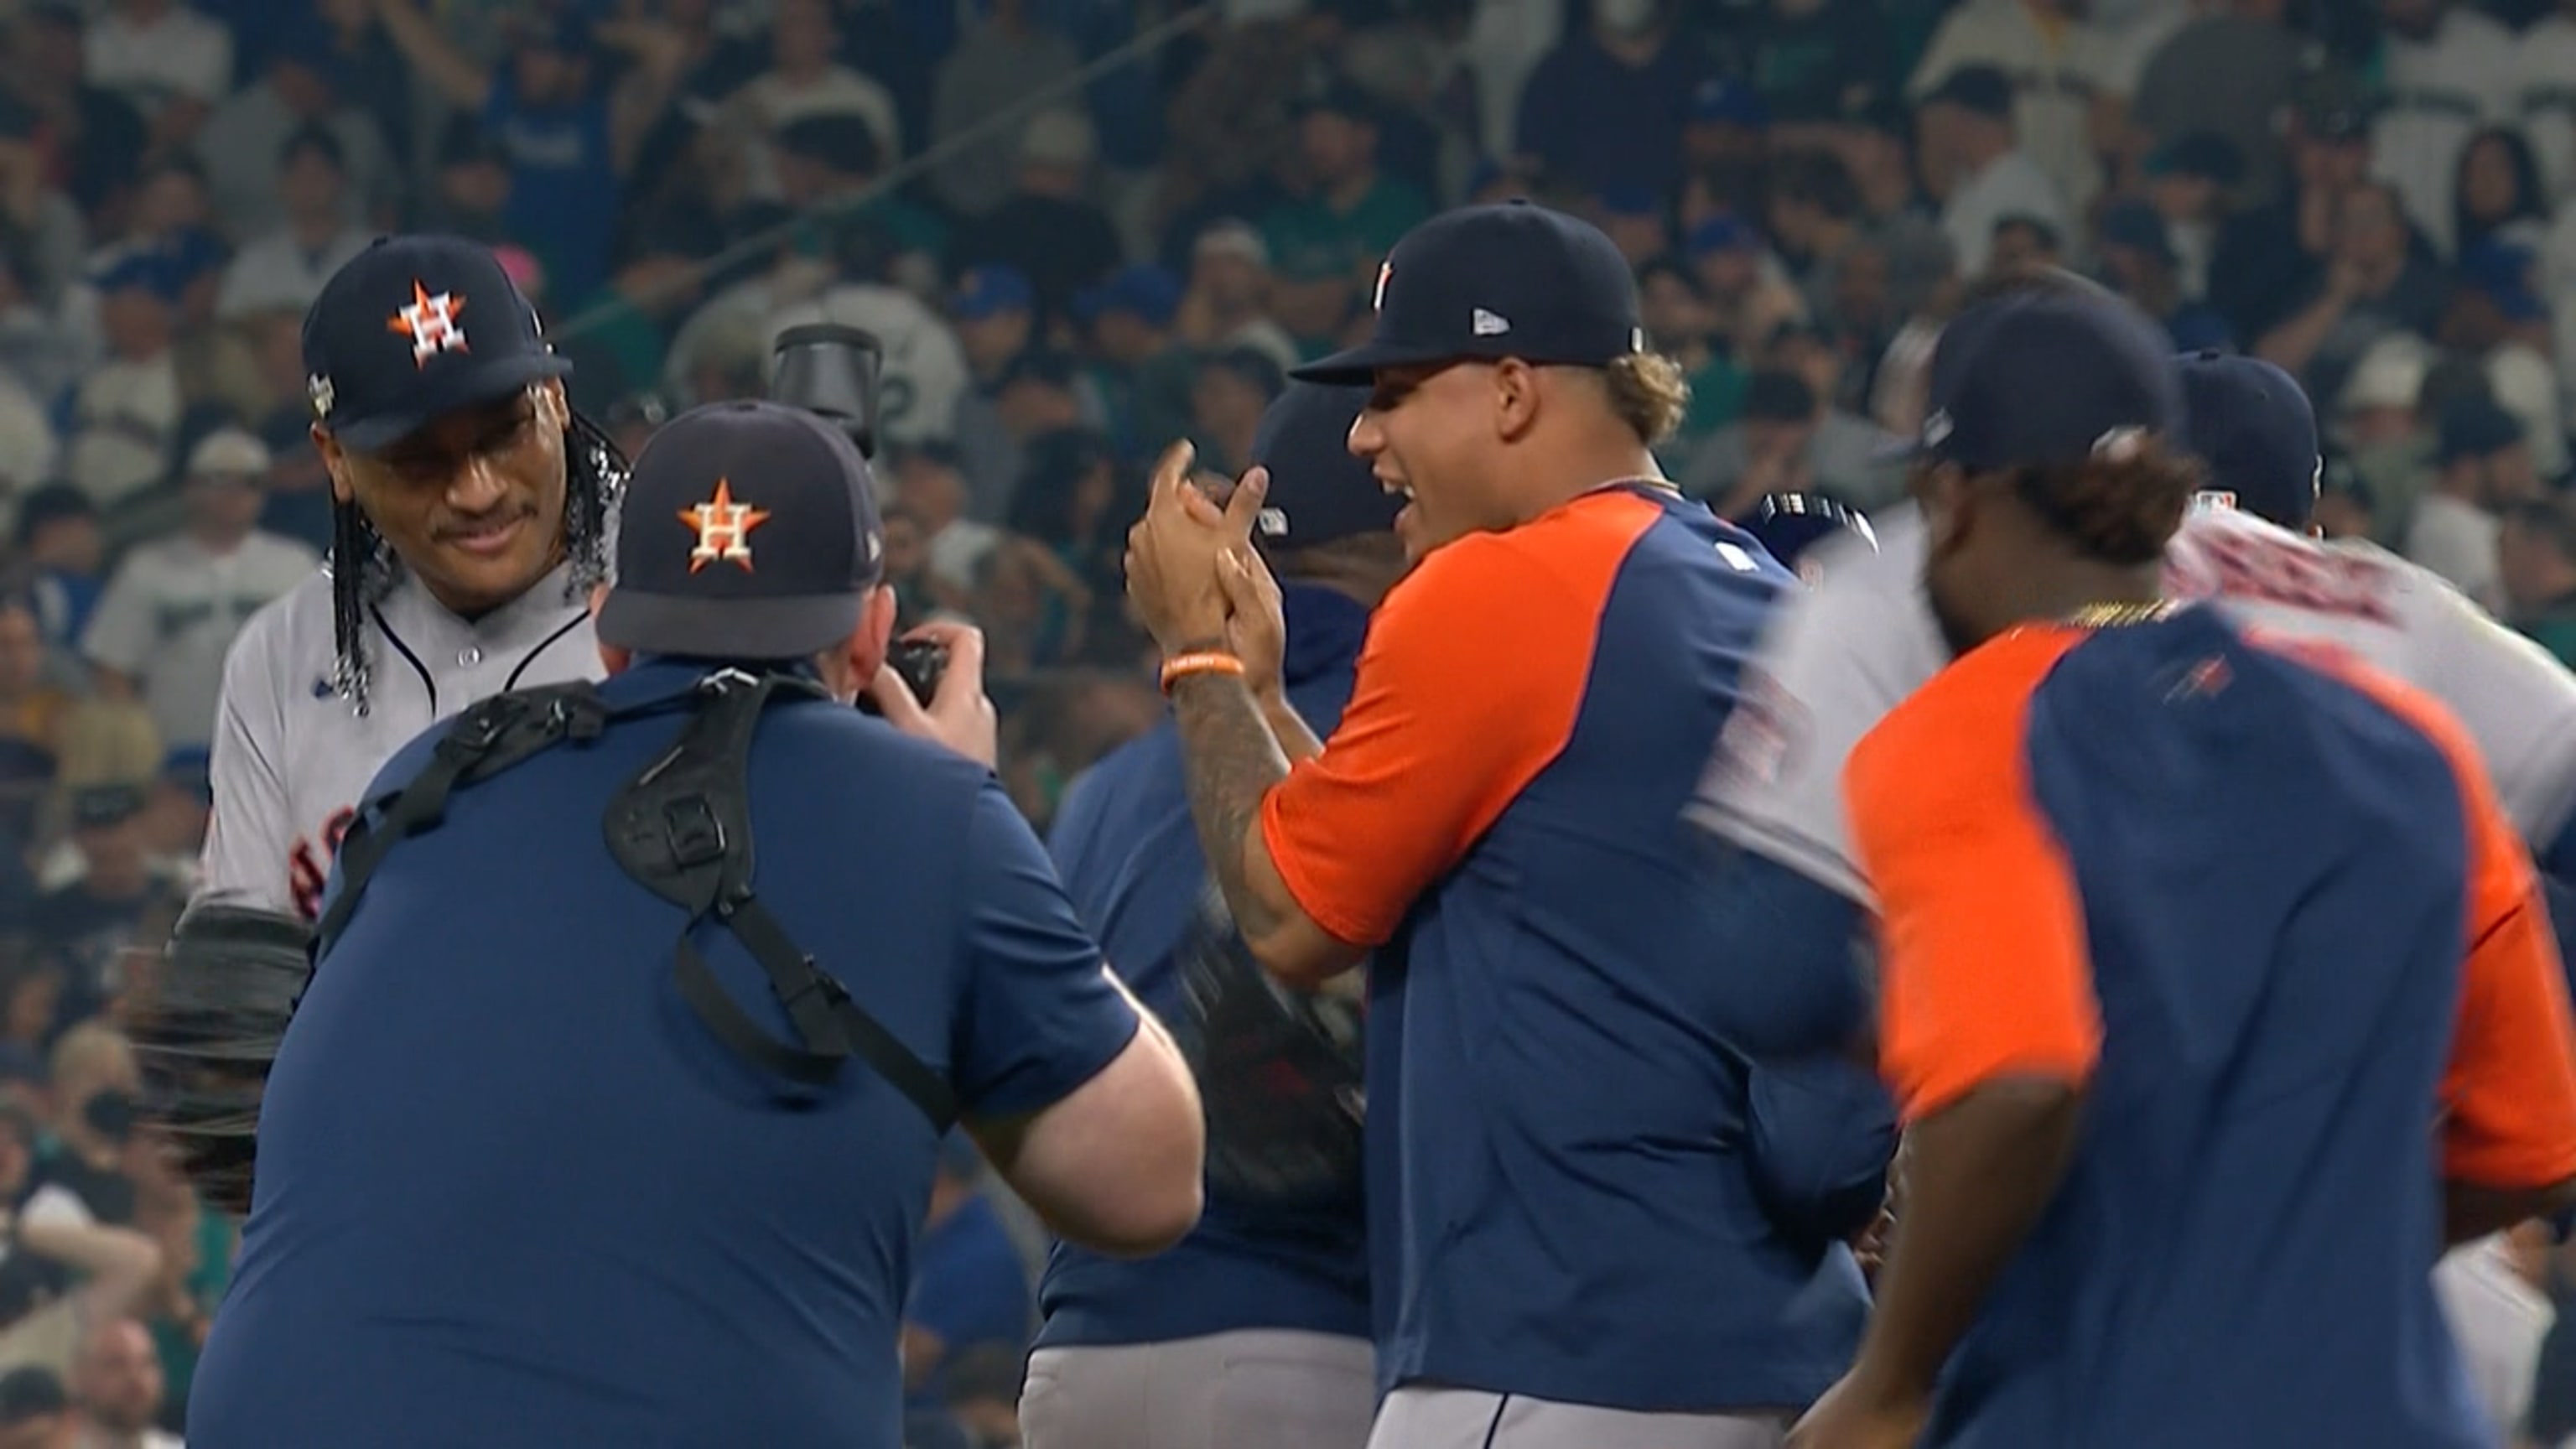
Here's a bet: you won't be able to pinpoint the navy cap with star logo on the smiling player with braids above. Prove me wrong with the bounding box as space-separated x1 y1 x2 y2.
304 235 572 454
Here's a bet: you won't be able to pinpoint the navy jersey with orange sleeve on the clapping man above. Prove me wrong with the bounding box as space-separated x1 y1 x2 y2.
1262 485 1883 1410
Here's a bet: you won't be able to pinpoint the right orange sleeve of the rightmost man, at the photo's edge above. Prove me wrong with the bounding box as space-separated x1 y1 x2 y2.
2336 662 2576 1188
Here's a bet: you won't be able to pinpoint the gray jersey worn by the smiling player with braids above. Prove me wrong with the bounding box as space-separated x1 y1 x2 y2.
199 567 603 921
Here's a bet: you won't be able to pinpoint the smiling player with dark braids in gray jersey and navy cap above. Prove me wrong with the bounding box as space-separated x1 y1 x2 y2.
201 237 623 921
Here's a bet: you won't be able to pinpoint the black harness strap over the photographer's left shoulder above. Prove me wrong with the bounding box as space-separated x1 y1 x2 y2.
314 681 610 962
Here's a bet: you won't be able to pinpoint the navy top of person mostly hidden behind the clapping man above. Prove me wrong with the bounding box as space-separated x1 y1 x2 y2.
1038 583 1368 1348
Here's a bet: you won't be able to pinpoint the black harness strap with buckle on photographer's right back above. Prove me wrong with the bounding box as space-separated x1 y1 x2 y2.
605 670 958 1132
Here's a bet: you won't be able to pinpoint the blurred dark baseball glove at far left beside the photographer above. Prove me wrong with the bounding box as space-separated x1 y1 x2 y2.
134 902 312 1214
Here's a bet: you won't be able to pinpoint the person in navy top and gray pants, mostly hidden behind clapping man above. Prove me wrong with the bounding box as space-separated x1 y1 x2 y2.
1021 382 1404 1449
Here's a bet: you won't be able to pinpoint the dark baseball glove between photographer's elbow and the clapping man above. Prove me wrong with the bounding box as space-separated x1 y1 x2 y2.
1172 885 1365 1207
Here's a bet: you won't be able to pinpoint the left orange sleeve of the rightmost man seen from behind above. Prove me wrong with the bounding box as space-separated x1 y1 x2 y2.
1841 629 2102 1122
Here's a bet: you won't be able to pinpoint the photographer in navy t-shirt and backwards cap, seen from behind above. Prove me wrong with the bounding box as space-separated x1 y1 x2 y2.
188 402 1203 1449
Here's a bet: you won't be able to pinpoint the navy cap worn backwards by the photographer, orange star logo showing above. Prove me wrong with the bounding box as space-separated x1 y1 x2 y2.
598 402 886 660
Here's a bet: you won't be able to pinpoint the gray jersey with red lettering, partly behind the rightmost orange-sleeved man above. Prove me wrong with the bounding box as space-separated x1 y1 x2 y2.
1690 503 2576 905
